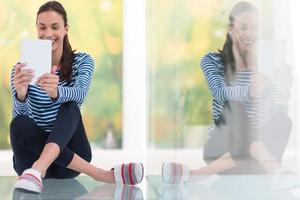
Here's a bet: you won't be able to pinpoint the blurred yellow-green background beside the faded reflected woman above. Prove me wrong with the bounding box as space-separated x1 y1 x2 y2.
147 0 272 148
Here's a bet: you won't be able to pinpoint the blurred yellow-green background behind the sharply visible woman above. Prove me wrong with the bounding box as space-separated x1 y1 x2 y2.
0 0 123 149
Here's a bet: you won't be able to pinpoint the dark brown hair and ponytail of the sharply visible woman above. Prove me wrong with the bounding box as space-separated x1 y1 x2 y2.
37 1 75 81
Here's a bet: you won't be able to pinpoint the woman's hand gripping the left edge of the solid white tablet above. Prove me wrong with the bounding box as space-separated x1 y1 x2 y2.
13 63 34 101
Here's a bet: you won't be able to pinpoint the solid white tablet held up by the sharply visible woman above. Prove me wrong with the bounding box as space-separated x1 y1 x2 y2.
20 39 52 84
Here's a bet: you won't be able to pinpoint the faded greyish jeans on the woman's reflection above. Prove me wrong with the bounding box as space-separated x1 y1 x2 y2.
203 101 292 174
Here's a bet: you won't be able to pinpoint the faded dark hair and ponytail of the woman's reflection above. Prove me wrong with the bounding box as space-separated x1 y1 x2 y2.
219 1 258 83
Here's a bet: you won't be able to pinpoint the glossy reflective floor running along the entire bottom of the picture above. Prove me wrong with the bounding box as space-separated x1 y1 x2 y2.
0 175 300 200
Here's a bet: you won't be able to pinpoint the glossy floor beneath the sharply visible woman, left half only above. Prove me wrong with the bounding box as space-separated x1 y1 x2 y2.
0 177 143 200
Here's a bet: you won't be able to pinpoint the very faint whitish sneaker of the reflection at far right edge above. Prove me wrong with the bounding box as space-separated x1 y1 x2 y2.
271 167 300 190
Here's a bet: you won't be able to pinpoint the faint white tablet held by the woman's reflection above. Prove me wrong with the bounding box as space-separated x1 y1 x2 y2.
257 39 287 77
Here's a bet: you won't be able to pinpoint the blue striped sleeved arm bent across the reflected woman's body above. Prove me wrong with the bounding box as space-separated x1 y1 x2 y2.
201 55 251 103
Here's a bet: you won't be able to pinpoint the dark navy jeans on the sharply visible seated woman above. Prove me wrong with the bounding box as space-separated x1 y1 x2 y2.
10 102 92 178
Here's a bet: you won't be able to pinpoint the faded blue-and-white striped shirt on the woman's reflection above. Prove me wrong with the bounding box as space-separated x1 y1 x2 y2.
201 53 278 128
